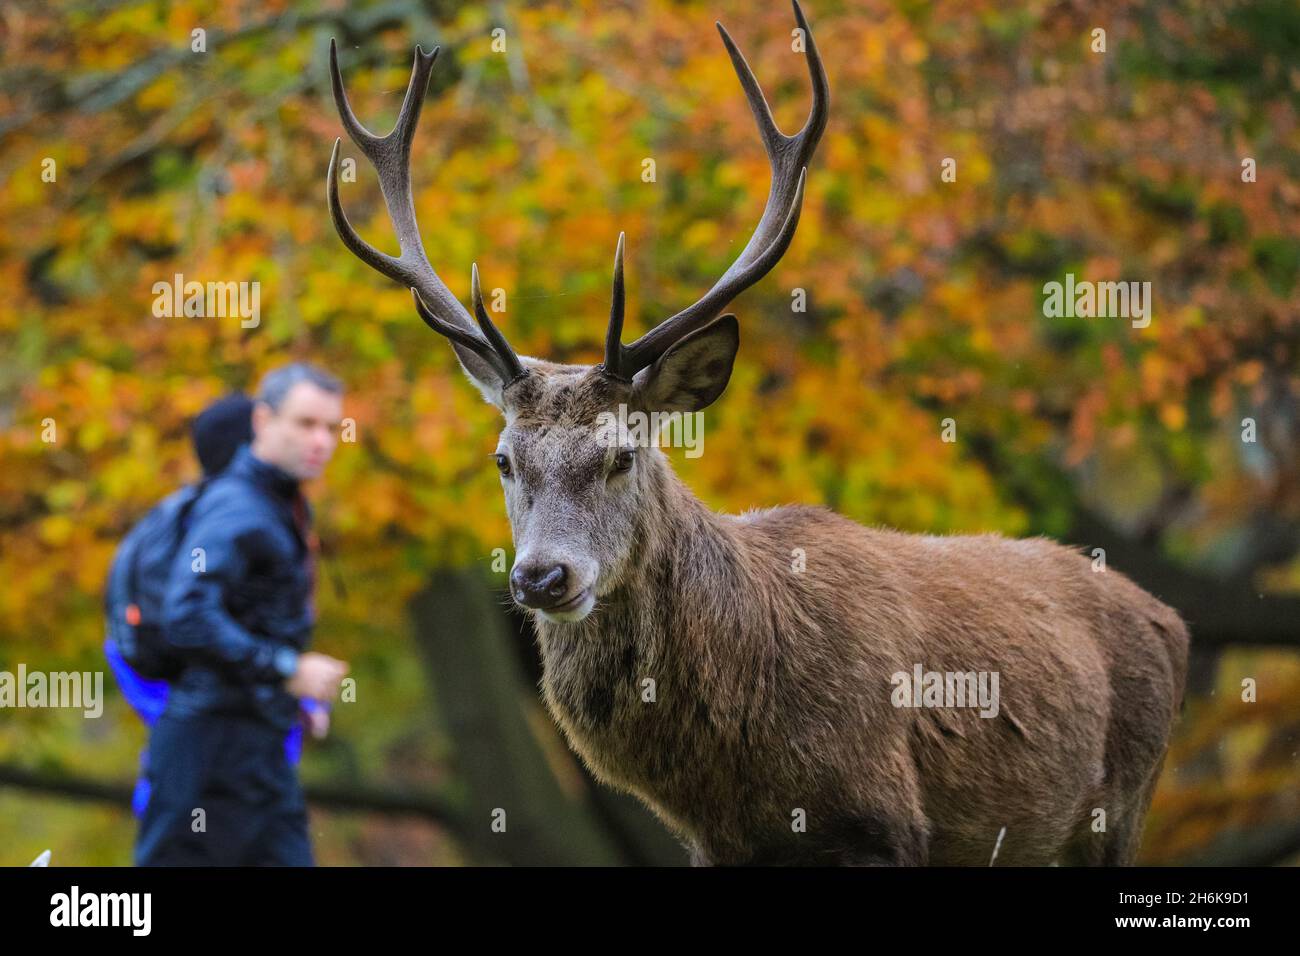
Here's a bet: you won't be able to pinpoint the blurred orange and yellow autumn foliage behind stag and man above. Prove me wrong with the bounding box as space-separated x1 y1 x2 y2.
0 0 1300 860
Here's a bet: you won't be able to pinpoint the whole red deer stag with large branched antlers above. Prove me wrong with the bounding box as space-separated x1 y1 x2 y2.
328 3 1188 865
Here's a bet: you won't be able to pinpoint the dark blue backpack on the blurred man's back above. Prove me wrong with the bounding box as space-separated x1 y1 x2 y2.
104 479 208 680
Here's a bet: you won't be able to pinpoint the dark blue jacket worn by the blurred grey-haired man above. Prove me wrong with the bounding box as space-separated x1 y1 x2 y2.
164 445 315 730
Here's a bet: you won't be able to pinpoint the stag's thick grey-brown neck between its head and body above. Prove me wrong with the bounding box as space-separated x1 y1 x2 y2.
538 462 770 842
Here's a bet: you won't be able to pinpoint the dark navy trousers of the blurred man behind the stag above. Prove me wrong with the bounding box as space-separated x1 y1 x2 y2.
135 711 313 866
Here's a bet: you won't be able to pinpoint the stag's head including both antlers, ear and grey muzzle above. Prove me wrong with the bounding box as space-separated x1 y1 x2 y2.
326 1 829 622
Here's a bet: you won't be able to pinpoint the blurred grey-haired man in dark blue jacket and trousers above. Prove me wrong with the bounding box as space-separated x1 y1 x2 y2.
135 364 347 866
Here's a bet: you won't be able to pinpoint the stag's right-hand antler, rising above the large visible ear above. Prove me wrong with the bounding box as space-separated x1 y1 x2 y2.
603 0 831 381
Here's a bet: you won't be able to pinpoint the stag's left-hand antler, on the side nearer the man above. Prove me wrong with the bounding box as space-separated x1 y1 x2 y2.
326 39 528 386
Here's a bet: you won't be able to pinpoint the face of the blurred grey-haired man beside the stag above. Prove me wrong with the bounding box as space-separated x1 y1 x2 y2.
252 381 343 481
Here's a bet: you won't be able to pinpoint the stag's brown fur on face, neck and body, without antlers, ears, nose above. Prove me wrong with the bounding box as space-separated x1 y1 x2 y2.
488 359 1188 865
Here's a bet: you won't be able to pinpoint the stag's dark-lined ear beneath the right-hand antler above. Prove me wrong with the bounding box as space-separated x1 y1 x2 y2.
632 312 740 412
